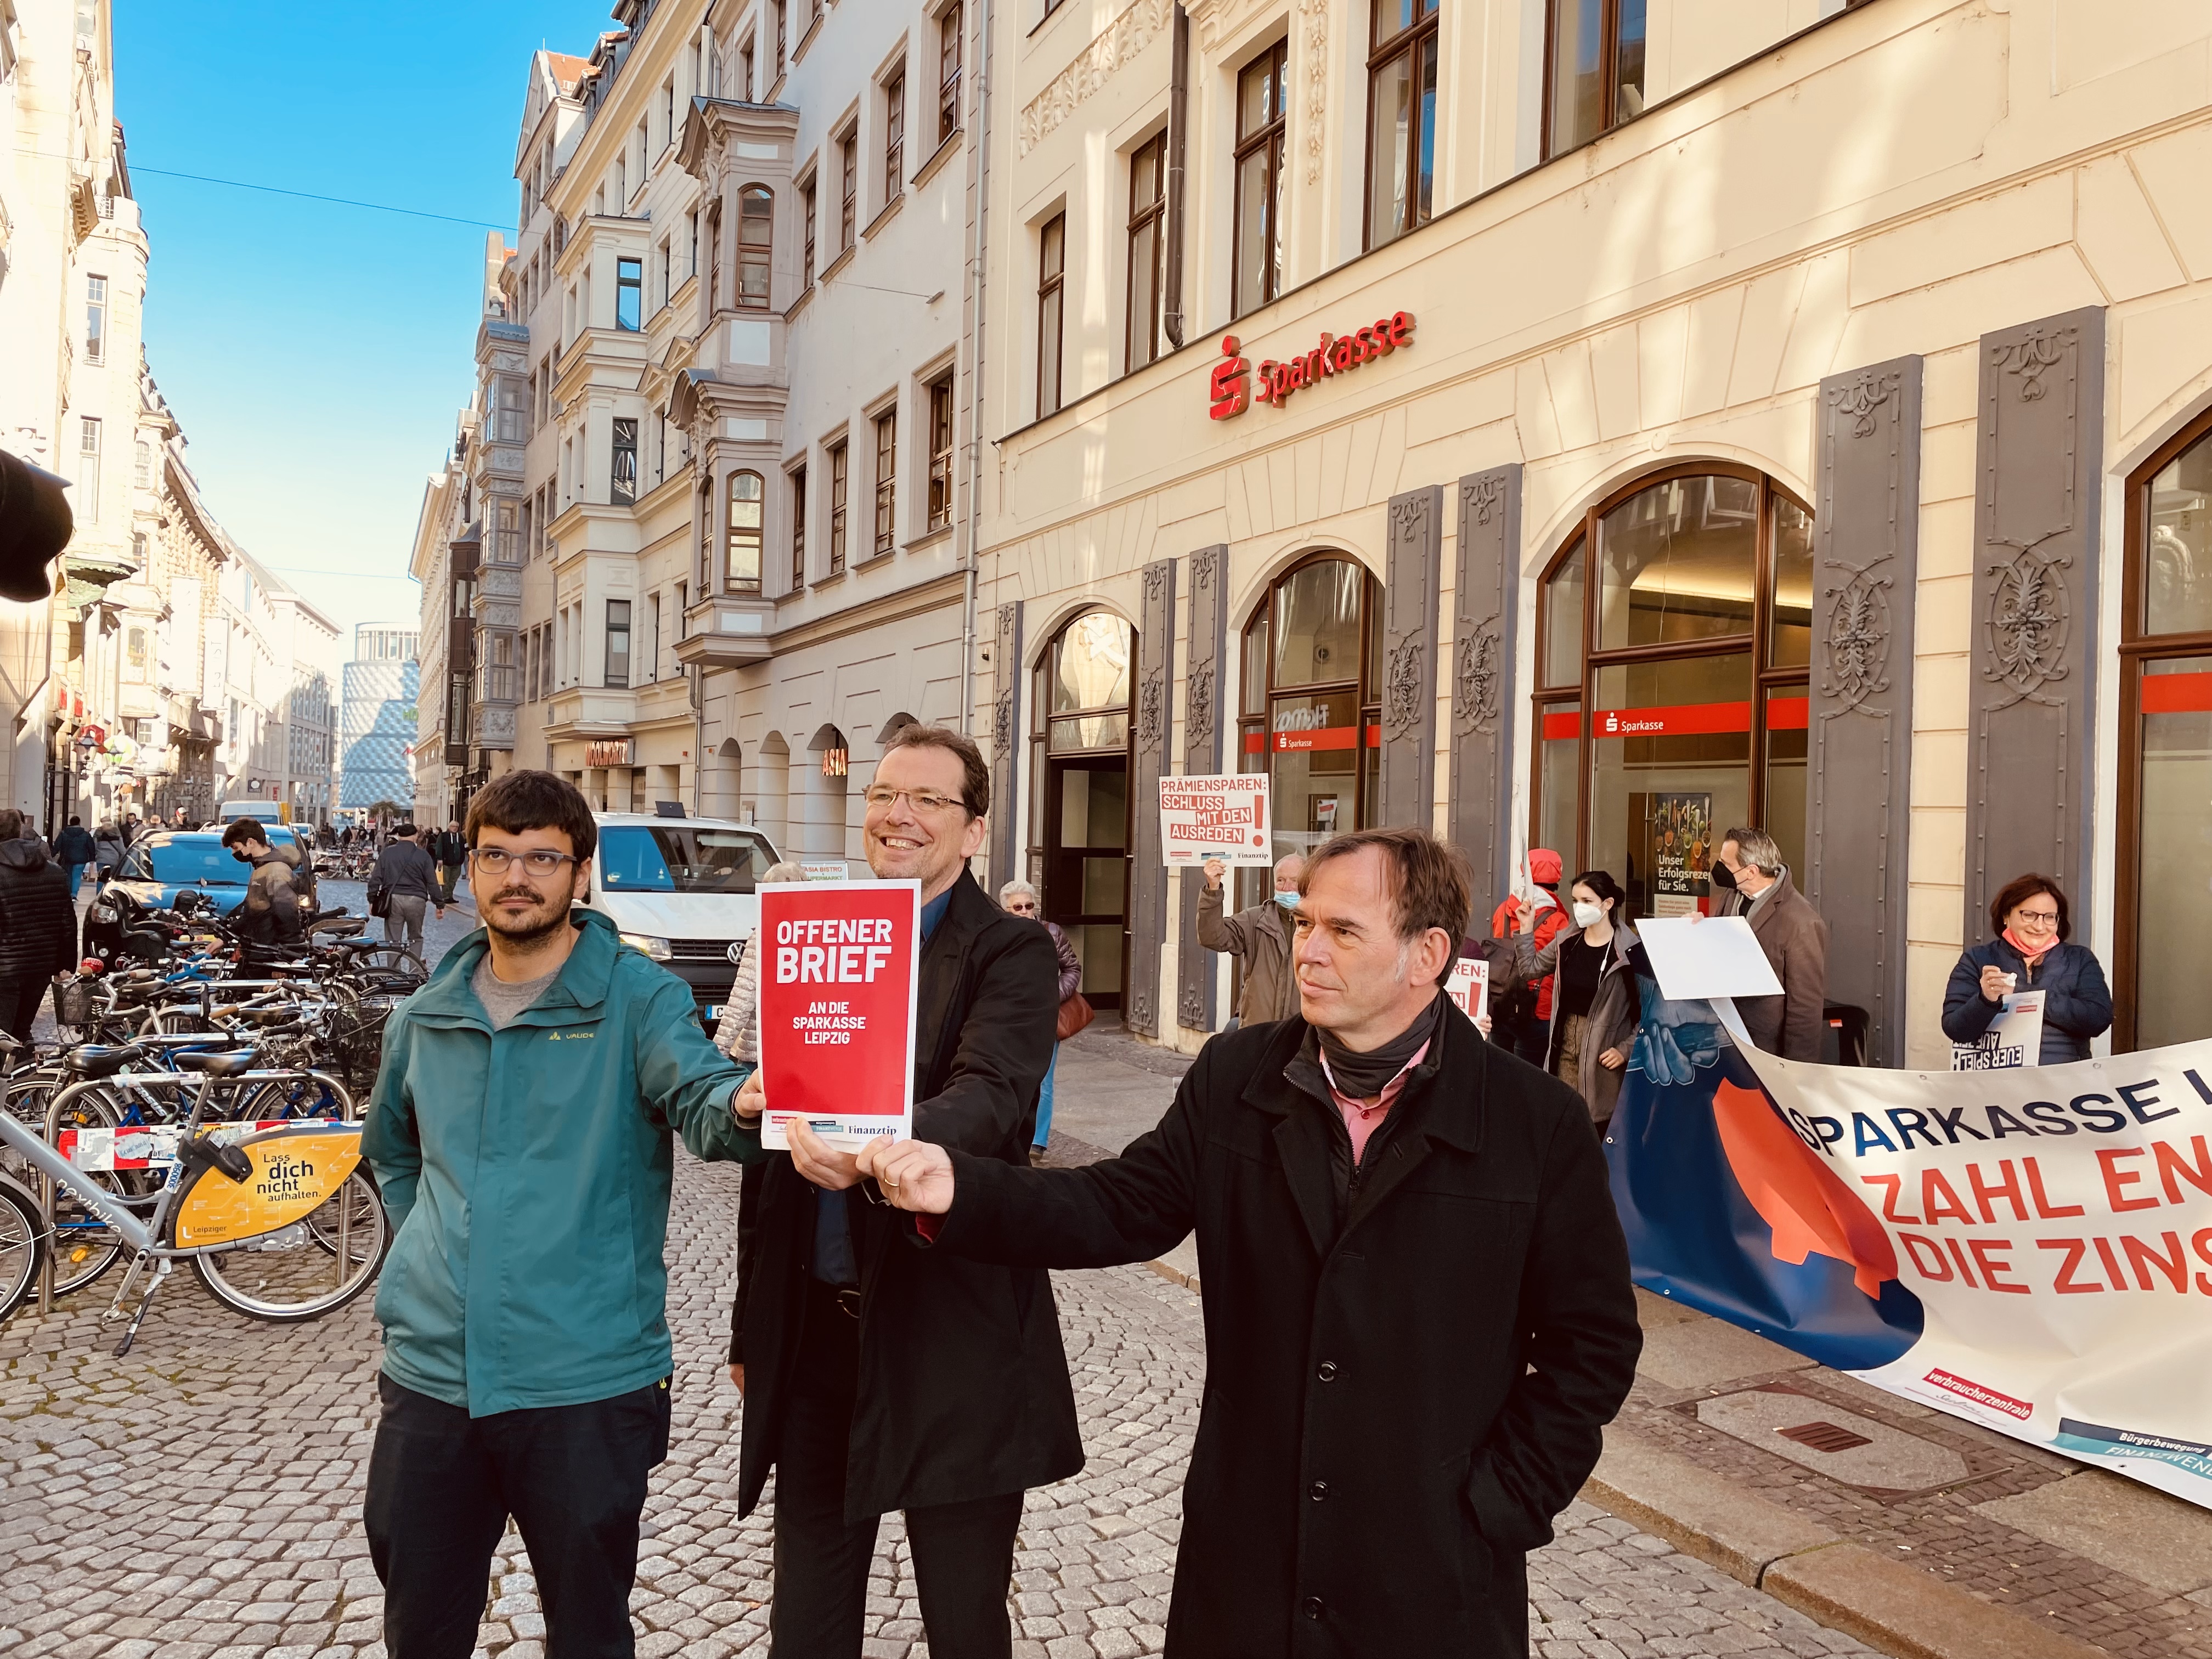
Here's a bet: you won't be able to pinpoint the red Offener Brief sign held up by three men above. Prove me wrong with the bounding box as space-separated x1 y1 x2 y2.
752 881 922 1148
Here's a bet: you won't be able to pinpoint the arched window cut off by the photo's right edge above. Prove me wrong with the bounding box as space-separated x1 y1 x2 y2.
2106 409 2212 1053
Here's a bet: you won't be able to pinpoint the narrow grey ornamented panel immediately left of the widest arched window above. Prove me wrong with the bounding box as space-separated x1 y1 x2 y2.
1447 460 1522 931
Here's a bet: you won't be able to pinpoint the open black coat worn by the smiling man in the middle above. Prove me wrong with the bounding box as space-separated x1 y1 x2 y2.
730 874 1084 1522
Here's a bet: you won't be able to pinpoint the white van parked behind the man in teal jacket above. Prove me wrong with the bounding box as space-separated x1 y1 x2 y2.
584 812 781 1024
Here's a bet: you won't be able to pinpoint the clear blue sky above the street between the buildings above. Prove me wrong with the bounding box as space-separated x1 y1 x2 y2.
115 0 615 654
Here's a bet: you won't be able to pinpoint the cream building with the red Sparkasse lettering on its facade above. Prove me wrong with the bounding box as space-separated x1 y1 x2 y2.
971 0 2212 1066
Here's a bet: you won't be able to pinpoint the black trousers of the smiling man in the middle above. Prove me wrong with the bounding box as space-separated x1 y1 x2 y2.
770 1278 1022 1659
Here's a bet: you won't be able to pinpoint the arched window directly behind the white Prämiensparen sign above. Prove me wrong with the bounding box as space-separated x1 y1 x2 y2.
1237 553 1383 905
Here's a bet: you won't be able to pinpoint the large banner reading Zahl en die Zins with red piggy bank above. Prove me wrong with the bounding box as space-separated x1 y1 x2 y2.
1606 1022 2212 1506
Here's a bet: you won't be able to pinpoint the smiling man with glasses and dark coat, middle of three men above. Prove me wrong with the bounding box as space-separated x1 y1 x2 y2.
730 725 1075 1659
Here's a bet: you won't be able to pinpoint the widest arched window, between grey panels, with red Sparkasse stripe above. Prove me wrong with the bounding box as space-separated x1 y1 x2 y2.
1528 462 1812 916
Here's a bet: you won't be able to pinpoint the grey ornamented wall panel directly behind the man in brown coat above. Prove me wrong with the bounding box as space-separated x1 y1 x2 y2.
1805 356 1920 1066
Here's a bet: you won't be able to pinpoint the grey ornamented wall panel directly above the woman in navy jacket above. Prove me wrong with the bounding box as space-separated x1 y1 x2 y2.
1966 305 2103 945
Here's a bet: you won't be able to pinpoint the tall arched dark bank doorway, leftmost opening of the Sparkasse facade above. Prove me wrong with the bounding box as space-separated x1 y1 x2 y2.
1029 611 1137 1011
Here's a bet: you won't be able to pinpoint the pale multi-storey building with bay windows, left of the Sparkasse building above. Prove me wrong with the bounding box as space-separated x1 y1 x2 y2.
431 0 975 858
